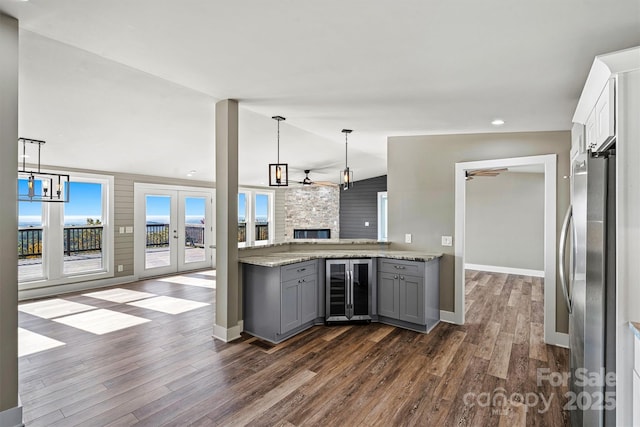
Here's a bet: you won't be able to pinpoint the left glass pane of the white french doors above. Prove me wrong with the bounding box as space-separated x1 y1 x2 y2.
144 195 171 268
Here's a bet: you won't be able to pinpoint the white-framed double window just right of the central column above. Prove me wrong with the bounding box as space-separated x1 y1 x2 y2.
238 190 273 247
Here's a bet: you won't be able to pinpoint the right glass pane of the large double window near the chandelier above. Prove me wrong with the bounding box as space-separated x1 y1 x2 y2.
62 182 103 275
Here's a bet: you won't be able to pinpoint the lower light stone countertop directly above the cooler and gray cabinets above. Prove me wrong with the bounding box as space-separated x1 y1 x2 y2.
239 249 442 267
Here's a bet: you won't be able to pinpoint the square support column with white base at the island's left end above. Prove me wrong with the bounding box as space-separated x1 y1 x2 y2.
213 99 242 342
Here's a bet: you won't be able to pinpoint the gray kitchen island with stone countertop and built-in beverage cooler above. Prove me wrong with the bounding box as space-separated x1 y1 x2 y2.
240 241 441 343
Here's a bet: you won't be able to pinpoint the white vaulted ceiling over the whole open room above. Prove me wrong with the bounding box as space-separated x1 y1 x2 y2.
0 0 640 185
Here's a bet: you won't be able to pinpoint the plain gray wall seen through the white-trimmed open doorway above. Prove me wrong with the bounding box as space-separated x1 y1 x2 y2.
464 172 544 271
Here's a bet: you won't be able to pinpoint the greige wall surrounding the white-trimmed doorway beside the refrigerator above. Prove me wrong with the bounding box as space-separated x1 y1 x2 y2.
387 131 571 332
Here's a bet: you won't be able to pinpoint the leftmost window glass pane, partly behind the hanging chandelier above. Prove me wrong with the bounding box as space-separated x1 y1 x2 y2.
18 179 44 282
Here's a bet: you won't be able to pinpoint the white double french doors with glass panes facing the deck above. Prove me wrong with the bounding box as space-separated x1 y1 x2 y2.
134 184 214 277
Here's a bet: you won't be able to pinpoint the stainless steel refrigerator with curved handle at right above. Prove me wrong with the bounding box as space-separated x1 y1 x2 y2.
560 149 616 426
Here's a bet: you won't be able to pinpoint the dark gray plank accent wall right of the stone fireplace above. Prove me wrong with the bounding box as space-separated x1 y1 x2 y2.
340 175 387 239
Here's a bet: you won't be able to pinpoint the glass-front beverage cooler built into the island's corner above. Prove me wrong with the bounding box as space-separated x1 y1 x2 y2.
326 259 373 322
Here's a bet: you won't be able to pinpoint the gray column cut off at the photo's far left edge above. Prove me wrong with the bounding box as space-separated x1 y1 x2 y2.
0 13 22 427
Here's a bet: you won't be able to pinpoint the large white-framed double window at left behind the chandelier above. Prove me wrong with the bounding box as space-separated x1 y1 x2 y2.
18 174 113 288
